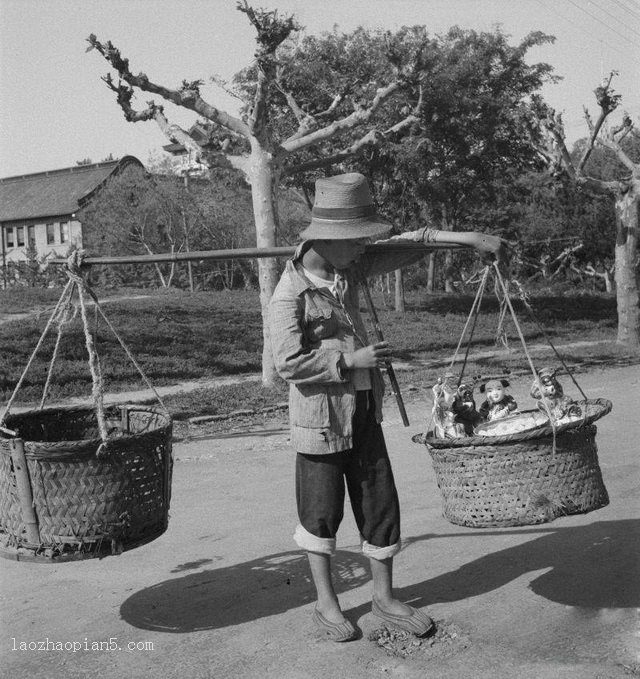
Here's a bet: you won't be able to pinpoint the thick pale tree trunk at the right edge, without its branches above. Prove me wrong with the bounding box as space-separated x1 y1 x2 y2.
615 191 640 349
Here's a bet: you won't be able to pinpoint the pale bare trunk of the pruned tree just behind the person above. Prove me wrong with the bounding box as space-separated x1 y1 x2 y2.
249 138 278 386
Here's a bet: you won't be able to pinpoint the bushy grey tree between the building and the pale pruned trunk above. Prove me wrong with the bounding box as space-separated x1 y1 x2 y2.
82 167 252 287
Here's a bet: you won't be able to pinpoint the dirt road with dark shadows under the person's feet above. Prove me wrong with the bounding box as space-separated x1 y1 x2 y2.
0 366 640 679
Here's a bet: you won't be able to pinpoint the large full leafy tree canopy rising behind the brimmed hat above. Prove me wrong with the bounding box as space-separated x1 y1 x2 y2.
264 26 553 290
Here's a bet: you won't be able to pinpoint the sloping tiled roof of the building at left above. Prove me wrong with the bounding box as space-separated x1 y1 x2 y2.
0 156 142 222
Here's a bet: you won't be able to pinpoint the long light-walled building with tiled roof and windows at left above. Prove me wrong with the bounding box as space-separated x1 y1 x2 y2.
0 156 144 270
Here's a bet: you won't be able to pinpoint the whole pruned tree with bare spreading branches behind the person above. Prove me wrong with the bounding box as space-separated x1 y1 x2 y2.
88 0 450 384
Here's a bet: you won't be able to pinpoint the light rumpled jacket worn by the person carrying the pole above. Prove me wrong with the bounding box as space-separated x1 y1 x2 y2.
268 243 422 455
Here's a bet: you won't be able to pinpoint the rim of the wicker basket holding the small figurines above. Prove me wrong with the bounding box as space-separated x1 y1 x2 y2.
411 398 613 448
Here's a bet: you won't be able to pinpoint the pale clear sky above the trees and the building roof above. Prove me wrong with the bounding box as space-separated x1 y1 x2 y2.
0 0 640 177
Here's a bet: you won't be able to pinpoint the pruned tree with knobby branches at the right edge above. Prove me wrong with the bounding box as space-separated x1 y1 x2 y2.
537 73 640 349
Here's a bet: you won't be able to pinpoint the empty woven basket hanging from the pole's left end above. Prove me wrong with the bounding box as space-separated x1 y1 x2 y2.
0 405 173 561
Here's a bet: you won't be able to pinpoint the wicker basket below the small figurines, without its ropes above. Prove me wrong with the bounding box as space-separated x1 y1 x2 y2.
413 399 612 528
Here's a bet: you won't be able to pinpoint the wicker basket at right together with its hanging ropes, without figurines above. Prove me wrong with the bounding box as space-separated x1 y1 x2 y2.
412 263 612 528
